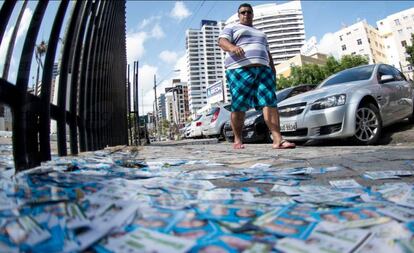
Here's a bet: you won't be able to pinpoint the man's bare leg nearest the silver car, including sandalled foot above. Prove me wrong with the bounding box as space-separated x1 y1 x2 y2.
263 106 295 148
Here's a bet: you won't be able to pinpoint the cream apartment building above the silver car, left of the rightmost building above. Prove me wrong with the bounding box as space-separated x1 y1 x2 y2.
335 20 387 64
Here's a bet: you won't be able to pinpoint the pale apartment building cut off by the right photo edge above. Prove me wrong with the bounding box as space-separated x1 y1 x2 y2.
377 8 414 78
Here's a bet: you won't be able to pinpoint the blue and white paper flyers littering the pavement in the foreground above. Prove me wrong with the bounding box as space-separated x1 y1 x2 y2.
0 151 414 253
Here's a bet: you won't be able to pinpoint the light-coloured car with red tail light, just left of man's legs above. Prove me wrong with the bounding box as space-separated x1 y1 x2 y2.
203 104 231 138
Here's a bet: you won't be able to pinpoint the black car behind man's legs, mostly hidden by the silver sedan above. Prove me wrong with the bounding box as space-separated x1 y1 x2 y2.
224 84 316 143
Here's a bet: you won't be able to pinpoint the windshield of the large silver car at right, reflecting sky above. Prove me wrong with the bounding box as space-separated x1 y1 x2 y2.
321 65 375 87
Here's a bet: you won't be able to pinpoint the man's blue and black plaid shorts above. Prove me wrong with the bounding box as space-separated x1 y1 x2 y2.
226 66 277 112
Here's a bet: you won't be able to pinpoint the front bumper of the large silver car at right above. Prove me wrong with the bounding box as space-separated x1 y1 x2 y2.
280 104 356 141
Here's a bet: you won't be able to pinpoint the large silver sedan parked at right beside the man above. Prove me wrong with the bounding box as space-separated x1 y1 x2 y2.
278 64 414 145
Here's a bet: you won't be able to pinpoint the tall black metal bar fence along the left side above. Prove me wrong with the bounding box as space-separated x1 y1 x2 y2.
0 0 128 171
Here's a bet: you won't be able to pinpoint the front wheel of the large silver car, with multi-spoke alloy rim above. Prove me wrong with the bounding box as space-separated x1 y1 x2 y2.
353 104 382 145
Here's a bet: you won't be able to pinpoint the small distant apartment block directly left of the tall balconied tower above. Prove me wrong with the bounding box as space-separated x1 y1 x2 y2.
165 79 190 127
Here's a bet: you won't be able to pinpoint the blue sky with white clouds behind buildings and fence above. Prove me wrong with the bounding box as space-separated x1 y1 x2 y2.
0 0 414 115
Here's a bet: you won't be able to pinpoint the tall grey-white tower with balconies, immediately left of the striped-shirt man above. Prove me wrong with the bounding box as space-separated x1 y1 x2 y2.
186 20 224 114
